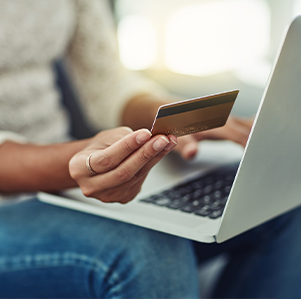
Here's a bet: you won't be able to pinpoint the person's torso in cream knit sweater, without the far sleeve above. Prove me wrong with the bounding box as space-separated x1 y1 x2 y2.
0 0 75 143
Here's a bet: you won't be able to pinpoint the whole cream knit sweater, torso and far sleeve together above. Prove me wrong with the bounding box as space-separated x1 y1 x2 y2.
0 0 164 144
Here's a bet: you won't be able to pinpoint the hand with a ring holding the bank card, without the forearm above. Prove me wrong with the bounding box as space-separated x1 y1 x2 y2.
69 127 177 203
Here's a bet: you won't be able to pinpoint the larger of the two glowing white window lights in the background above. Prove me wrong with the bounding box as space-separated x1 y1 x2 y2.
165 0 270 76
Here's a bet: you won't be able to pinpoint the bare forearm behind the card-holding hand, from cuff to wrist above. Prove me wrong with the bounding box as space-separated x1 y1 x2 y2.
0 140 89 194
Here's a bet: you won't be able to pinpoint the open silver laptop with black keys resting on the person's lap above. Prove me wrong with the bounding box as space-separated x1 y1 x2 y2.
38 16 301 243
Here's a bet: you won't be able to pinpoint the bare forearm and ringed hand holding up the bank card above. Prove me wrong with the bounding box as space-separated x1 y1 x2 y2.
0 127 177 203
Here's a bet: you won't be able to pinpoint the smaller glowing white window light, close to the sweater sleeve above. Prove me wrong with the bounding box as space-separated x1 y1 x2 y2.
117 15 157 70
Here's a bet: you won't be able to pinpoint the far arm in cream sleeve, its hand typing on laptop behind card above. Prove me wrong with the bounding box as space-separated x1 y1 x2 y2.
67 0 251 163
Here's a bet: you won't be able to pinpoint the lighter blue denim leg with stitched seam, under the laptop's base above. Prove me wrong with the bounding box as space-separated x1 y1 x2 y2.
0 200 199 298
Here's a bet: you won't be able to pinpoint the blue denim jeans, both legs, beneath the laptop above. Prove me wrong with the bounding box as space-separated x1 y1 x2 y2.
0 200 301 298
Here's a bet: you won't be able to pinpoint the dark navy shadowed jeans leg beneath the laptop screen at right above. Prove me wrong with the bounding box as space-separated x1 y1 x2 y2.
195 208 301 298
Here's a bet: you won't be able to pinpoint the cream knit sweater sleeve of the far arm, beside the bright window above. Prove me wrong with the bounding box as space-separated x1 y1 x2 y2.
66 0 167 129
